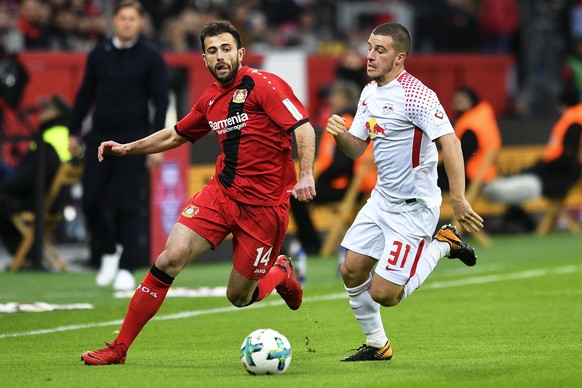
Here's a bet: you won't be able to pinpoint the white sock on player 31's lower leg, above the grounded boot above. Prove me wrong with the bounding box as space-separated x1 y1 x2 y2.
346 275 388 348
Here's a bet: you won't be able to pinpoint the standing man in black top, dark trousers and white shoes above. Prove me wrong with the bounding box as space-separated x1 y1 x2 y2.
70 0 169 290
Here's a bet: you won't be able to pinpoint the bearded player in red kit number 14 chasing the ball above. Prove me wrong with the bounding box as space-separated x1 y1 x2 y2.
81 21 315 365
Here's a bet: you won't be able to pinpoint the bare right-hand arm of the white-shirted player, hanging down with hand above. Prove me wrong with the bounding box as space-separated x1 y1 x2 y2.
437 133 483 232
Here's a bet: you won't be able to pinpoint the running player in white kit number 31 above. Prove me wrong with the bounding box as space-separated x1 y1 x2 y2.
326 23 483 361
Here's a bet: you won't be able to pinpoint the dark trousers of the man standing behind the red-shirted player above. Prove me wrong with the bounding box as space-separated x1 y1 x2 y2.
82 146 147 271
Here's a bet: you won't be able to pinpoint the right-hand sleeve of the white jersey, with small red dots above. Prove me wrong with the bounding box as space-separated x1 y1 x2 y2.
406 87 454 141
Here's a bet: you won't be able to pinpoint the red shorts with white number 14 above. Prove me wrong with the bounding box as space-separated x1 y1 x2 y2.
178 178 289 279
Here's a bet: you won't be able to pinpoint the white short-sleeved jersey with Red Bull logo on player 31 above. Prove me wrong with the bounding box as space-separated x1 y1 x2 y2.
349 70 454 212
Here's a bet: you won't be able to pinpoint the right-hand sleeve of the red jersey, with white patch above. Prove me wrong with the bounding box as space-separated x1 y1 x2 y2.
255 72 309 132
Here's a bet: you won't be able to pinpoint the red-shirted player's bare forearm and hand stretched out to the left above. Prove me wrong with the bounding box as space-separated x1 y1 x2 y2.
97 128 187 162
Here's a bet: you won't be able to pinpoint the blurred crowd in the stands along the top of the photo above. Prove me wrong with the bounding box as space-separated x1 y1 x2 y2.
0 0 582 115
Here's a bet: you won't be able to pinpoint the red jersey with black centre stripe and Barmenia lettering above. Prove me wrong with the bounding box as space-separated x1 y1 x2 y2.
176 66 309 206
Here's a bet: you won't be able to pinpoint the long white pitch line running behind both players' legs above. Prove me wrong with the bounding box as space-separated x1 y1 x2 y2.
0 265 582 339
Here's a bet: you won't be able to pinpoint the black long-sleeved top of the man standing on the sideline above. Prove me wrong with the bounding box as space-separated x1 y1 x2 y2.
69 38 169 143
